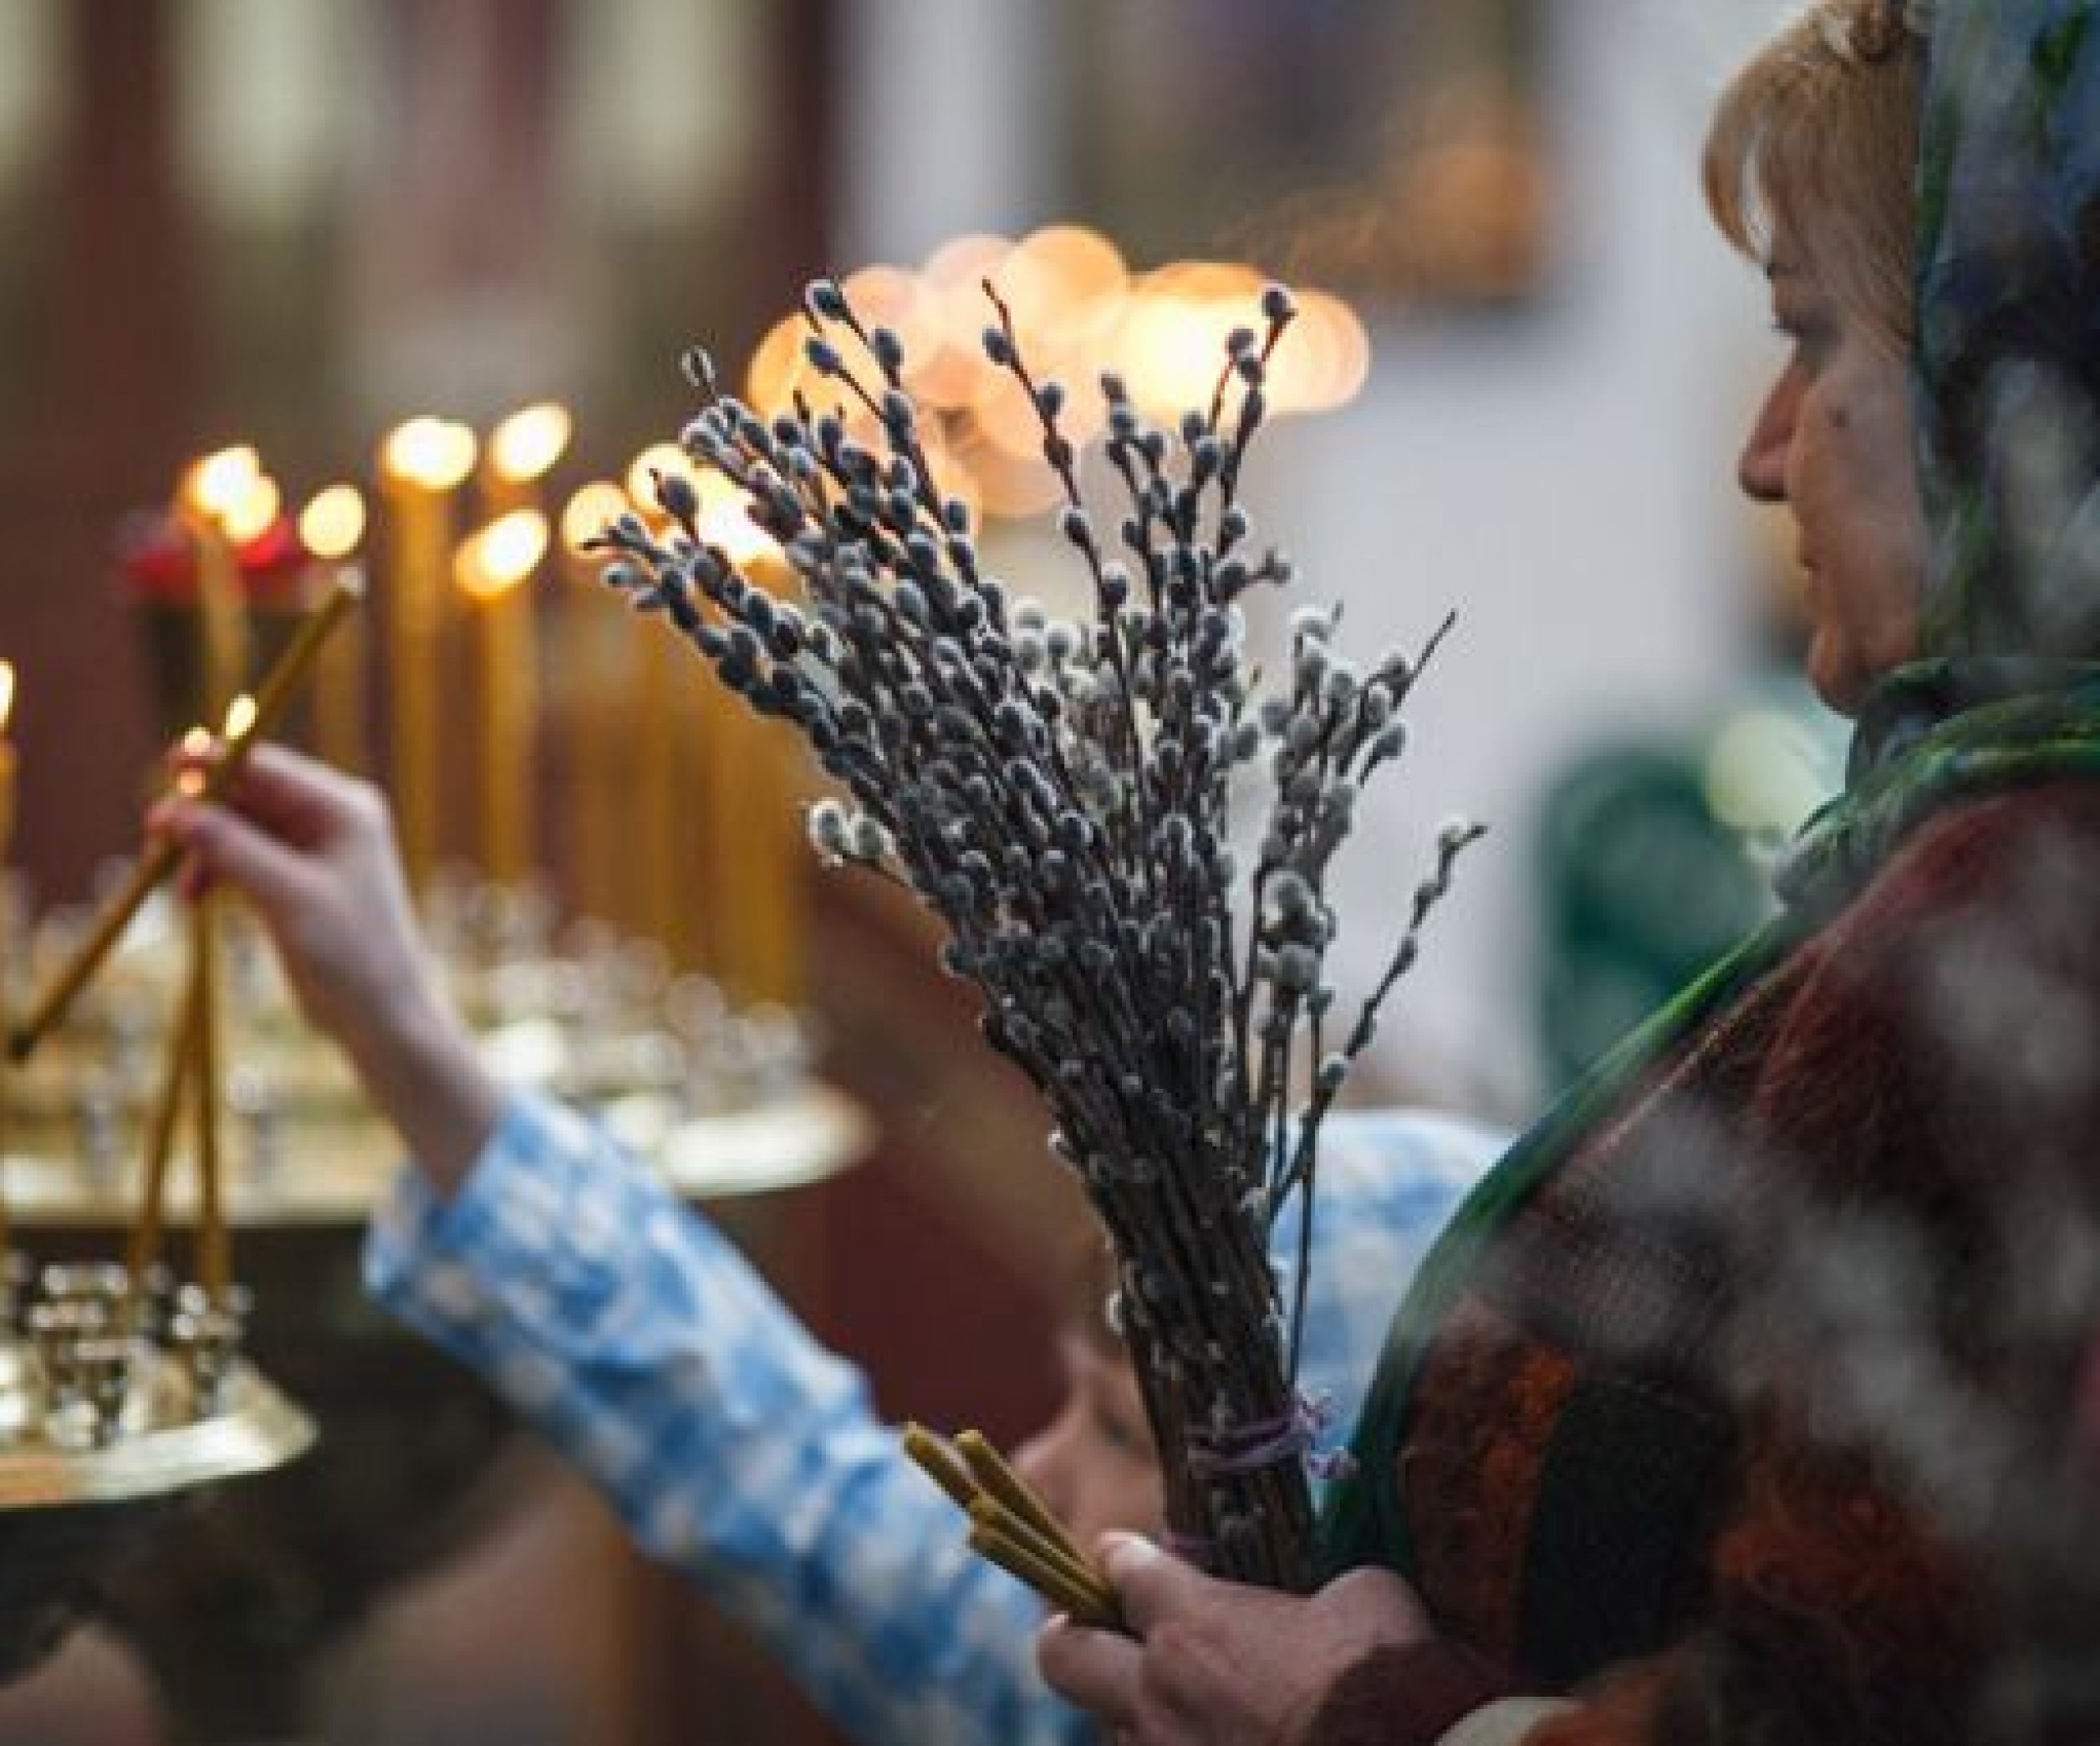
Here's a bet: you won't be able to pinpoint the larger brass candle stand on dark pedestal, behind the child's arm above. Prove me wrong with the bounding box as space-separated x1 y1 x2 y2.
8 878 871 1746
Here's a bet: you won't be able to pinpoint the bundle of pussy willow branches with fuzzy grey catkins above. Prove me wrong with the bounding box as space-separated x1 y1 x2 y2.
604 282 1476 1589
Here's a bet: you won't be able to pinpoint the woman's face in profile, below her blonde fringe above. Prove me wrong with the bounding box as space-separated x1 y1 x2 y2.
1739 248 1926 714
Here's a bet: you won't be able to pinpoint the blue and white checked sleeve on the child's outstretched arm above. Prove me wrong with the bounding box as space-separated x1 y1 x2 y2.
365 1097 1090 1746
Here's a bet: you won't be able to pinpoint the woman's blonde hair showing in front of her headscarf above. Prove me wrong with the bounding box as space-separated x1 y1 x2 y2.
1703 0 1926 353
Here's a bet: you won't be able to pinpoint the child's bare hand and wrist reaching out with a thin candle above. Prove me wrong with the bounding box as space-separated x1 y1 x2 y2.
147 746 502 1192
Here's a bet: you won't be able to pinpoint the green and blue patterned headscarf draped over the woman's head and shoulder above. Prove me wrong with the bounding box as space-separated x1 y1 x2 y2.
1323 0 2100 1574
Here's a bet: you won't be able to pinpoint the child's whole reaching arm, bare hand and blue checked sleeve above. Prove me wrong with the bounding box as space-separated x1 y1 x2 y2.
151 746 1083 1746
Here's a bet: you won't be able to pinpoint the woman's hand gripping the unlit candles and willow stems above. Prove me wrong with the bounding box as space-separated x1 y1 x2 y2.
1035 1534 1432 1746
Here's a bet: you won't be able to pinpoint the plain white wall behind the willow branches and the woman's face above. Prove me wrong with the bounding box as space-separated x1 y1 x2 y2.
840 0 1814 1111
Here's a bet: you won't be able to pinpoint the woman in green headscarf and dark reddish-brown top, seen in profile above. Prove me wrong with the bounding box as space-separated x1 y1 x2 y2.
1042 0 2100 1746
